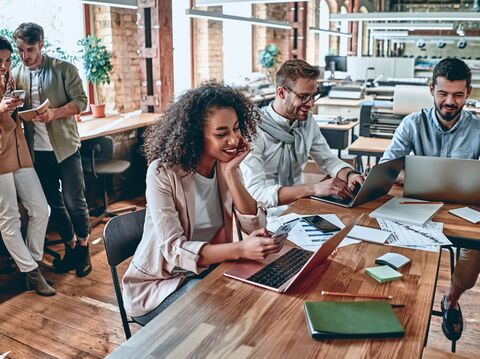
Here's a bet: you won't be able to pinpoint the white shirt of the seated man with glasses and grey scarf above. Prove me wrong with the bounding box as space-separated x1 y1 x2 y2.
240 103 350 207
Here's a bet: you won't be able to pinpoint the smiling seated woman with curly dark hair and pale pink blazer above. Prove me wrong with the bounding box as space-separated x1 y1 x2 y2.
122 82 283 324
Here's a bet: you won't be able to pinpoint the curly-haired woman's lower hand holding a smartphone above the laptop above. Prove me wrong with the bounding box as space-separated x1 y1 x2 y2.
240 228 287 259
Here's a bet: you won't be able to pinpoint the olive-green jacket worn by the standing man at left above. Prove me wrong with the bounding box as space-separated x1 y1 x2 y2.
13 55 88 163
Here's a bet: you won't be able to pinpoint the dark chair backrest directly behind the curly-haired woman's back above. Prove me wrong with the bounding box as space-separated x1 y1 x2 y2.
103 209 145 267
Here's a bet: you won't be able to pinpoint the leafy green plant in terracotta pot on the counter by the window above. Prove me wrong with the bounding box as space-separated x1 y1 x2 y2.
78 35 112 118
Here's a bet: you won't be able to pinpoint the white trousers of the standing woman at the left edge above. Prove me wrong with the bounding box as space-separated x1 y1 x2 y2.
0 168 48 273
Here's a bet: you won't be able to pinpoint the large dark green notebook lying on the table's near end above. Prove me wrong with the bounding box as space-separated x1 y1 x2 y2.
304 301 405 339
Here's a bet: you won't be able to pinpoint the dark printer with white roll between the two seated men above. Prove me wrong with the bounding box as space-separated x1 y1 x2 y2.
359 85 433 138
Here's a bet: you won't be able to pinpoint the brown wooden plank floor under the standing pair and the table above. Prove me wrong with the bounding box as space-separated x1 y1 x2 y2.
0 198 480 358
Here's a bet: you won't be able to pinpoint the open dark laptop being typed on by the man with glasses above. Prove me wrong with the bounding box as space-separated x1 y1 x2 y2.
311 157 404 207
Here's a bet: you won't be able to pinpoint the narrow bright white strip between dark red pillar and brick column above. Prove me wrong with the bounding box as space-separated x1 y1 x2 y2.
172 0 192 97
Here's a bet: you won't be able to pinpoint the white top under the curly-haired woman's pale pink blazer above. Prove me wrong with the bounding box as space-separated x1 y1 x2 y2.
192 172 224 242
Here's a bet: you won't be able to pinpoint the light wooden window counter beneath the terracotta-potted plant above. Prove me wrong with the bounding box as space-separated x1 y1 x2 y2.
77 113 160 141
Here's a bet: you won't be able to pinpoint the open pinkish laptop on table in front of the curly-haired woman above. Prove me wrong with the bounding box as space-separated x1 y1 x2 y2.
224 215 363 293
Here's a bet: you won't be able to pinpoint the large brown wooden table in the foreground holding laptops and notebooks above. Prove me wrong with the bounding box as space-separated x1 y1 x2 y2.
105 187 462 358
